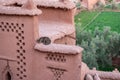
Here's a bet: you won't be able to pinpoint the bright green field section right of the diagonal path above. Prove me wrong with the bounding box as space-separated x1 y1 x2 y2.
87 12 120 32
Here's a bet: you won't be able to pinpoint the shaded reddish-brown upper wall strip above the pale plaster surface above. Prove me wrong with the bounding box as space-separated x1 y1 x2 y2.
38 7 75 25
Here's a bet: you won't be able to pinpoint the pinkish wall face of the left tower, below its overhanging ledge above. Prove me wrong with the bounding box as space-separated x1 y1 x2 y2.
0 15 37 80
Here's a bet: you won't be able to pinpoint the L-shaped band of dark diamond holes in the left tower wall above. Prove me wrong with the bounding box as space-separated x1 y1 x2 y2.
0 22 27 80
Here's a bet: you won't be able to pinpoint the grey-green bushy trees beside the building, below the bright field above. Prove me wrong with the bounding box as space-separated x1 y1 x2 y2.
77 27 120 70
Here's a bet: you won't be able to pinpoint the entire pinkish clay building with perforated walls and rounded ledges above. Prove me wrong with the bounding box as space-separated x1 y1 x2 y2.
0 0 120 80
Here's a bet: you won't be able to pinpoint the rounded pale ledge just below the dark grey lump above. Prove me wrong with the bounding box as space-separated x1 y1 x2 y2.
34 44 83 55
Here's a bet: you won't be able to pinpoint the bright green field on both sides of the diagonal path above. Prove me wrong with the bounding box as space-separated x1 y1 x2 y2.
75 11 120 33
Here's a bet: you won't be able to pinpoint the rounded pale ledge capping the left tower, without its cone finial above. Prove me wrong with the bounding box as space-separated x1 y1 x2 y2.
0 5 42 16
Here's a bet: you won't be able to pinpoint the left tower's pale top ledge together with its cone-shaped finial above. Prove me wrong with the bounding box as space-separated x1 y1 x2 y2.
0 0 42 16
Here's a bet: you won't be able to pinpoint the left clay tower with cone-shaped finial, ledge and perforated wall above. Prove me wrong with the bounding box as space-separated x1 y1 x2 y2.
0 1 41 80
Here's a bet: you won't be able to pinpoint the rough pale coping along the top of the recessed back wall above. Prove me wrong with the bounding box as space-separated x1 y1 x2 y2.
17 0 75 9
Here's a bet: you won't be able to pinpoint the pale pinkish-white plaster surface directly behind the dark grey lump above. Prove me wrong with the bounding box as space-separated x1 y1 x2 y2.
39 21 75 42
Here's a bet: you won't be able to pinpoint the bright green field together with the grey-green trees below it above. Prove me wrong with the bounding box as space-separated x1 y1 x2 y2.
75 11 120 71
